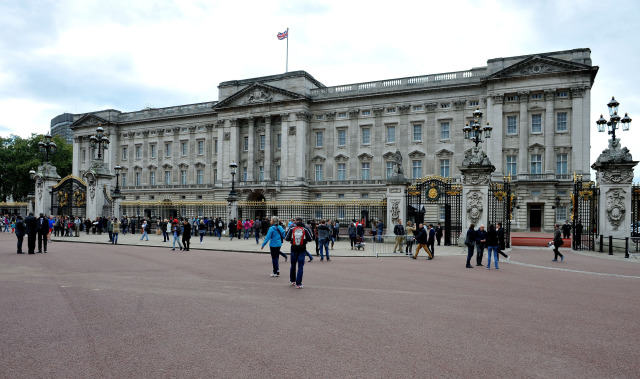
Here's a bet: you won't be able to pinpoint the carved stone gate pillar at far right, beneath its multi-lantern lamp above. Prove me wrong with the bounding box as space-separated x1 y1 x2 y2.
591 138 638 243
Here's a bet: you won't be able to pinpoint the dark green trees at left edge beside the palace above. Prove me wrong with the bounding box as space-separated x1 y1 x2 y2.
0 134 73 201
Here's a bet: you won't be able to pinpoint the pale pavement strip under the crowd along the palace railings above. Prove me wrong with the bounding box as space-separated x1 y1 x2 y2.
51 233 467 257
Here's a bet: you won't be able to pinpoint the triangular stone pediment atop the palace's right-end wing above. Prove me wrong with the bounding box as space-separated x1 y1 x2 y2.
485 55 598 80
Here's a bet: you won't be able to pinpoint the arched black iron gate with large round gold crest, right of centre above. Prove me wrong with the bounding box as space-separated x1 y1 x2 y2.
407 176 462 245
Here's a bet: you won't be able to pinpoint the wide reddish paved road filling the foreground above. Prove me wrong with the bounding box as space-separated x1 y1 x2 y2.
0 234 640 378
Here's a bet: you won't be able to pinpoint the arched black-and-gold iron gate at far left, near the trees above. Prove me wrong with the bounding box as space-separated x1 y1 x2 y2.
51 175 87 218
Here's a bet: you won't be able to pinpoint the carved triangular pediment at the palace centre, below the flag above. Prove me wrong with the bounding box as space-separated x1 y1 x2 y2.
214 83 308 110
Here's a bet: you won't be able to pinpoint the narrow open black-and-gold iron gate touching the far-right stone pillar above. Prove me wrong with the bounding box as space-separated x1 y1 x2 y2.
571 175 600 250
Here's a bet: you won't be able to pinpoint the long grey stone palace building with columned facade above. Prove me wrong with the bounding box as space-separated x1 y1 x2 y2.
70 48 598 231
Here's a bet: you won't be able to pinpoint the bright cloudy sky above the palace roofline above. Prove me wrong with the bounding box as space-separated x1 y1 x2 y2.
0 0 640 180
